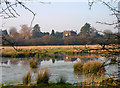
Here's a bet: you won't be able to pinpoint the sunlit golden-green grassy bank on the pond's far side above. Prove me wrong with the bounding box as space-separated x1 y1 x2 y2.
2 45 120 58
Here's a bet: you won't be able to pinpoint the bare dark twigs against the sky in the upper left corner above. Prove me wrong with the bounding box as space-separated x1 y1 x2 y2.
0 0 36 26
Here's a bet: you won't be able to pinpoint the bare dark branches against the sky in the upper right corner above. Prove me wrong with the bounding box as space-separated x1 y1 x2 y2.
88 0 120 45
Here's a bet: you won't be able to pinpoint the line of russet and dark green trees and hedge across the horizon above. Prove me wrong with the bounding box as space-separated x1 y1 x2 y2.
0 23 118 46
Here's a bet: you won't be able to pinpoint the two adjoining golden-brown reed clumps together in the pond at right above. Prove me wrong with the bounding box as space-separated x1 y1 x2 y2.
73 60 105 75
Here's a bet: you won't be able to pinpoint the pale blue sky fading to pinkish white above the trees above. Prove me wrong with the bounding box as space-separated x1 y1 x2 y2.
2 2 117 33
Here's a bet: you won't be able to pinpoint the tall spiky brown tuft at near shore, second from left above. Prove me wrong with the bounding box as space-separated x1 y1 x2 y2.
37 68 50 84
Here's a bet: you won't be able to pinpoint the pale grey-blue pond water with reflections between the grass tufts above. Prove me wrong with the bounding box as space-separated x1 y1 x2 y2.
0 55 118 84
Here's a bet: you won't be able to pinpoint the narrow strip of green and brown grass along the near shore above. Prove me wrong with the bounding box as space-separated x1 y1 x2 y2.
2 78 120 88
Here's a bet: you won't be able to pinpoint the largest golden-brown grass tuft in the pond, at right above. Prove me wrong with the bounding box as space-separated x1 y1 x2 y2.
83 60 105 75
